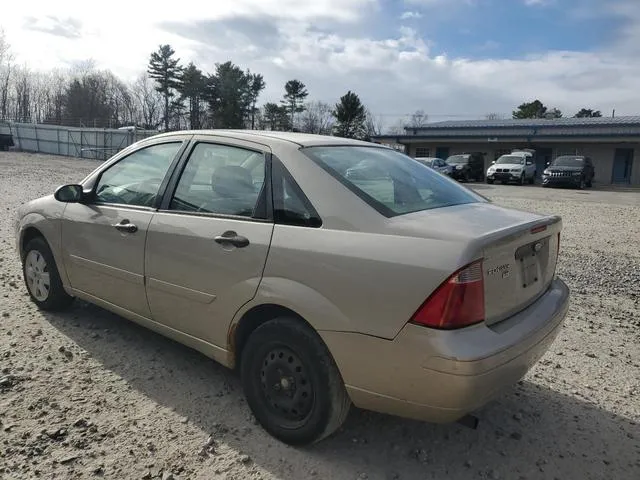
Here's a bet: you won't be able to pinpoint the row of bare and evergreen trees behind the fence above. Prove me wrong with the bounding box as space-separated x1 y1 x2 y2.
0 32 382 139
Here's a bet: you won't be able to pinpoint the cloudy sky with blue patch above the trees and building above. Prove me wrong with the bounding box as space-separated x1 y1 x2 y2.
0 0 640 125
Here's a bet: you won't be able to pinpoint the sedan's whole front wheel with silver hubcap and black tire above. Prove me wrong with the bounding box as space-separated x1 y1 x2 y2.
22 237 73 311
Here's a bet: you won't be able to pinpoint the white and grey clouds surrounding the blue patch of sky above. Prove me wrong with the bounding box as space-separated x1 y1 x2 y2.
0 0 640 122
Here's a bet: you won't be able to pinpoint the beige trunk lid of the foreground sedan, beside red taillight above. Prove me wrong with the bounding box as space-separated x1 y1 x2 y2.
384 202 562 325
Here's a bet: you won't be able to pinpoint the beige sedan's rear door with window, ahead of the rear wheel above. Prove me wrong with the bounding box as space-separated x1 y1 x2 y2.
145 136 273 347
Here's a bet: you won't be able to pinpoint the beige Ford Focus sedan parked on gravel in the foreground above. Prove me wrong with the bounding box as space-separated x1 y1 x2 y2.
16 130 569 445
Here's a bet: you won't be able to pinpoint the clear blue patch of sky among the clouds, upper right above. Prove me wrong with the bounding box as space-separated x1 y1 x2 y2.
390 0 623 59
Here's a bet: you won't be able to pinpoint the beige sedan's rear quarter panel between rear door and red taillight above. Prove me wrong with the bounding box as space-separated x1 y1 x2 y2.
252 225 476 339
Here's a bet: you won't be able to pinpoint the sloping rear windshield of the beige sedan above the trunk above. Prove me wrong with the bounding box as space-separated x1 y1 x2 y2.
302 146 486 217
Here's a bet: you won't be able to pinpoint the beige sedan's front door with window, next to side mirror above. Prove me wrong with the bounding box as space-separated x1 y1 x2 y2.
62 138 183 317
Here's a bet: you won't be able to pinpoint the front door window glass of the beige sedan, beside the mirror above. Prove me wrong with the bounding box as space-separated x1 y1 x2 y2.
95 142 182 207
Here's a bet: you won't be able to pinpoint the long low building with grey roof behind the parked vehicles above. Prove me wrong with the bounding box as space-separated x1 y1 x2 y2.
372 116 640 186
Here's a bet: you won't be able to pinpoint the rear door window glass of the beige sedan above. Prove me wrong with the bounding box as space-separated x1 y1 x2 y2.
169 143 266 218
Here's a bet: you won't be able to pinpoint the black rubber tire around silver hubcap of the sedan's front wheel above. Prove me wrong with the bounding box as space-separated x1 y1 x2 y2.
22 237 73 312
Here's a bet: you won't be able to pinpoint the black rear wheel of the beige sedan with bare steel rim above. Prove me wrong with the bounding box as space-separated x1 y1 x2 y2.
240 317 351 445
